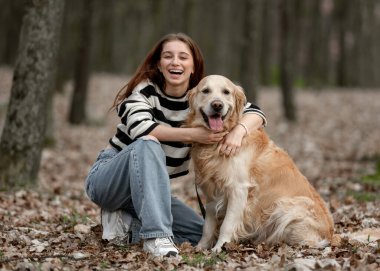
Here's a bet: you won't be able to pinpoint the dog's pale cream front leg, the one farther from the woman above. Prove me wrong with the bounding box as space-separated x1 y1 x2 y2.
212 187 248 252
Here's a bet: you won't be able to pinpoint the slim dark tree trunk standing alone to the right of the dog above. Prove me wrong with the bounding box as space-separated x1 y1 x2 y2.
280 0 296 121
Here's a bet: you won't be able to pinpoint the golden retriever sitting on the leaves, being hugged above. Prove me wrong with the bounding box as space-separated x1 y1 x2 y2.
185 75 334 252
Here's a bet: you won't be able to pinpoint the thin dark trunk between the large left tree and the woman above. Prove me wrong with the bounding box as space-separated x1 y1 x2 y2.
69 0 94 124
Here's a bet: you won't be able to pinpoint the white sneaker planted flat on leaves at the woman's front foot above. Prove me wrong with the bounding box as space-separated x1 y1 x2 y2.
143 237 178 256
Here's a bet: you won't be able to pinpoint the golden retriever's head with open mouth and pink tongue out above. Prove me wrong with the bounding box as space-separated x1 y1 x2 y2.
186 75 246 131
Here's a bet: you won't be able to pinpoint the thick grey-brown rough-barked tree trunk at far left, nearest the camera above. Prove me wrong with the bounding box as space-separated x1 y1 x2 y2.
0 0 64 190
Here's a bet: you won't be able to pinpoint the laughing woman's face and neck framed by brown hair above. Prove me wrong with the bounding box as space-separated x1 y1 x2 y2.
158 40 194 95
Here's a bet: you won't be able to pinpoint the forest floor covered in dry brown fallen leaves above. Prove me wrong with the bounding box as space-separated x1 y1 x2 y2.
0 67 380 270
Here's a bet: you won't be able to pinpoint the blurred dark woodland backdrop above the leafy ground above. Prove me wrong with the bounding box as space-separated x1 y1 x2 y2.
0 0 380 93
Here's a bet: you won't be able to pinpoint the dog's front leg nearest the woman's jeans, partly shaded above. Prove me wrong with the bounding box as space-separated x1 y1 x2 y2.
197 200 217 249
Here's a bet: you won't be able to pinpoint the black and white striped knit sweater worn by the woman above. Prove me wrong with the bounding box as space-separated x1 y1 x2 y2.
109 81 266 179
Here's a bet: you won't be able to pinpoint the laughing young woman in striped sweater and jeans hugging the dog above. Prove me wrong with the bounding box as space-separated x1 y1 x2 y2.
86 33 266 256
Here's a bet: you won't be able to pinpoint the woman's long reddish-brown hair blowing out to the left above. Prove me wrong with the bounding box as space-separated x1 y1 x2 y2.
112 33 204 108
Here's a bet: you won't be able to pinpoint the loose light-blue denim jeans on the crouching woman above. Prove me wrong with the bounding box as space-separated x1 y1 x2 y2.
85 138 204 245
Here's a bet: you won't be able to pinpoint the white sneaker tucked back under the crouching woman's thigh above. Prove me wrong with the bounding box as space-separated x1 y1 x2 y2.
101 209 132 246
